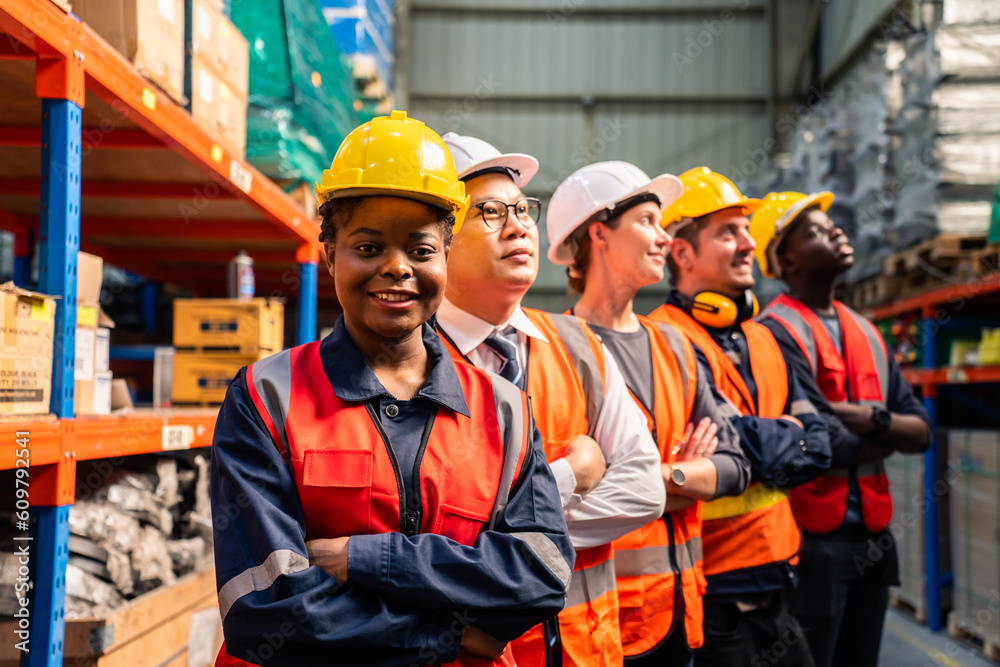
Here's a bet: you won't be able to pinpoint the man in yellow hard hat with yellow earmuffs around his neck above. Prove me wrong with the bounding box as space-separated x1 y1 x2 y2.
649 167 830 667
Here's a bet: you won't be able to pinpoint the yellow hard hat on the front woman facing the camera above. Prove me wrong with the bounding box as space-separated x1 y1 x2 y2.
316 111 469 232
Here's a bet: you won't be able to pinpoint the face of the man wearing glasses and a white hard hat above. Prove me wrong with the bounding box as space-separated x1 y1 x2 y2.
448 174 538 314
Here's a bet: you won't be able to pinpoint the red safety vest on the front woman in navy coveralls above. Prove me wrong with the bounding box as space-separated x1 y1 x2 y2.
215 341 531 667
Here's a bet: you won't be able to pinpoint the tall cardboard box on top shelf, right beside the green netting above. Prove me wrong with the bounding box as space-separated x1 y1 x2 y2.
184 0 250 155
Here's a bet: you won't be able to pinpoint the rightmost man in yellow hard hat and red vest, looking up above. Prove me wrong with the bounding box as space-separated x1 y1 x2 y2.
750 192 931 667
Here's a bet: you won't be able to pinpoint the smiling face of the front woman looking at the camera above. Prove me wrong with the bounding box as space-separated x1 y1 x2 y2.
326 197 448 341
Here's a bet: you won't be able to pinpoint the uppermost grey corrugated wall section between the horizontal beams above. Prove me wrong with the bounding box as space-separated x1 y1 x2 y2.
410 11 770 96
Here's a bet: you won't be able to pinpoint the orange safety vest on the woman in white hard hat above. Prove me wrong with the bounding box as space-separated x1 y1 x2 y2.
614 317 705 656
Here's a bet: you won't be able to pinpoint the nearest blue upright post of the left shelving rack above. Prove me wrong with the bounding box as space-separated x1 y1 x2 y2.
21 99 81 667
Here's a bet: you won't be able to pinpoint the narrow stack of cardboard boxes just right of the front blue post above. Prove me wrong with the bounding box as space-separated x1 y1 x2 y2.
74 252 115 415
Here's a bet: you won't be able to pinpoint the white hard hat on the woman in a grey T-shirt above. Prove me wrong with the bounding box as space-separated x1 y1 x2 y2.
545 161 684 266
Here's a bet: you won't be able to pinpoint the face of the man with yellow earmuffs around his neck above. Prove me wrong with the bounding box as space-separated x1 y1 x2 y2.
670 208 756 298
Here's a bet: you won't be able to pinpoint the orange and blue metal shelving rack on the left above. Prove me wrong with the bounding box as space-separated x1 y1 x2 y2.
0 0 335 667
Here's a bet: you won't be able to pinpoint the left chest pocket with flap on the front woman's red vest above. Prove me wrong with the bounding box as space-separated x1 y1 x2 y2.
293 450 376 539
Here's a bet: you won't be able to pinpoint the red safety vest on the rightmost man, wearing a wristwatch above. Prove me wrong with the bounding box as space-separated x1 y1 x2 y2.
761 294 892 533
